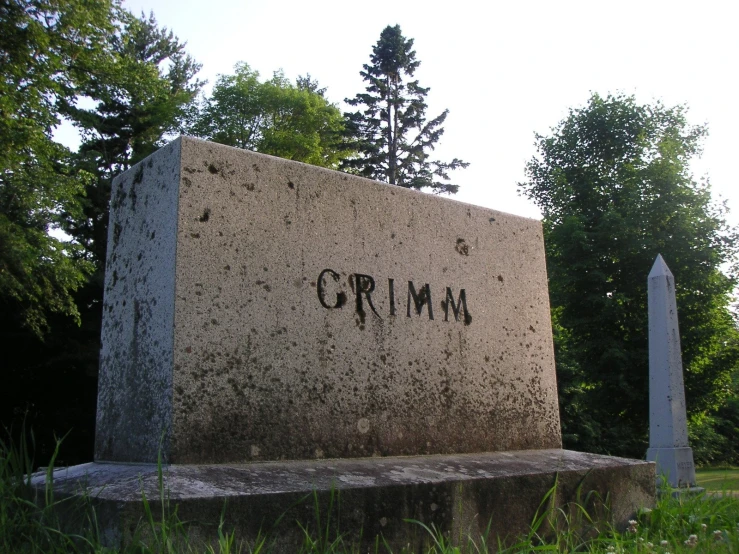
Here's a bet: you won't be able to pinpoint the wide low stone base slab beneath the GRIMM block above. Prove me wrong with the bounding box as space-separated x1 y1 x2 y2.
33 449 655 552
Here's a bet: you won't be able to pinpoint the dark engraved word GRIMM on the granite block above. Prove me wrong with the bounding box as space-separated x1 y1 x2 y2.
316 269 472 325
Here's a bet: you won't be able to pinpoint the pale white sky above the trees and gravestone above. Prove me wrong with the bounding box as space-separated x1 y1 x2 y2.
118 0 739 224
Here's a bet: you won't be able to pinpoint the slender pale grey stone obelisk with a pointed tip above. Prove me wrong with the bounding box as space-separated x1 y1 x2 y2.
647 255 695 487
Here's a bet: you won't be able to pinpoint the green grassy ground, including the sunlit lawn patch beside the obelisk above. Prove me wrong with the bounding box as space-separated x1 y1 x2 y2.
0 434 739 554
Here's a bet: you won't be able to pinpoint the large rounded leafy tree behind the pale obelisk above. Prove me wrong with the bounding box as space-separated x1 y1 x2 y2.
521 95 739 457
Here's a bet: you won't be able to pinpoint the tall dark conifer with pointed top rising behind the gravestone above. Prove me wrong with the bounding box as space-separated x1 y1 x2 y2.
342 25 469 193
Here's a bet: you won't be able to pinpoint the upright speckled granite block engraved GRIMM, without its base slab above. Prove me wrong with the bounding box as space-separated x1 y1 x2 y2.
96 138 561 463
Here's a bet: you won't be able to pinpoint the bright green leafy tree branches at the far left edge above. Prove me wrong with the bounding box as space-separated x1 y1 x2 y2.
0 0 114 337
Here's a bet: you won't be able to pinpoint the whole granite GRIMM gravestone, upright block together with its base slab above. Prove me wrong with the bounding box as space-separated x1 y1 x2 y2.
40 138 654 550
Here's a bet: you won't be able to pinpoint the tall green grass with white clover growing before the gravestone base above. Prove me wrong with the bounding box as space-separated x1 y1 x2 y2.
0 434 739 554
